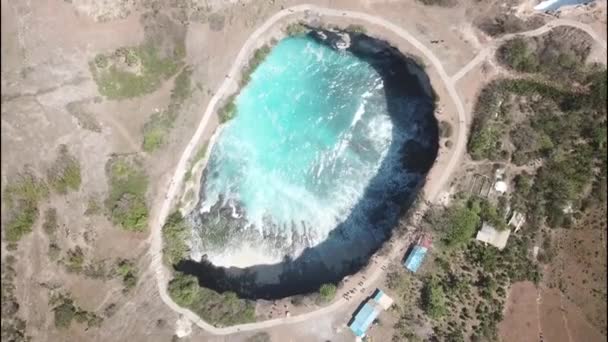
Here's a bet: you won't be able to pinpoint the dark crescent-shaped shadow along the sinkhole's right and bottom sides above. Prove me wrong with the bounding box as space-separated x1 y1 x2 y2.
175 29 438 299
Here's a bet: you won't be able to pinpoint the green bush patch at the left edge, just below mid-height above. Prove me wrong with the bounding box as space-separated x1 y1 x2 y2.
2 172 49 243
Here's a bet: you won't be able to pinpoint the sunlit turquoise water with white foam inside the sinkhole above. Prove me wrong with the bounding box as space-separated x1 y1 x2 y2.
193 36 422 267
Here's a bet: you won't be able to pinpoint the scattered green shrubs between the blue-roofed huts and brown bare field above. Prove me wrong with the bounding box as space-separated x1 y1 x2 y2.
386 197 541 341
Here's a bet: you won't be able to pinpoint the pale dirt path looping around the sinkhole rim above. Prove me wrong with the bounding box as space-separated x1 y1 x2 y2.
150 5 606 335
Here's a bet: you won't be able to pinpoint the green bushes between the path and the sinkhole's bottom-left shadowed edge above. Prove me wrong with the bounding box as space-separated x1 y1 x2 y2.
168 272 255 327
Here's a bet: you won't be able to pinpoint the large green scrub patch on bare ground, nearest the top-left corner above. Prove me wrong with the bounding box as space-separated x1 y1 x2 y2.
89 43 183 100
